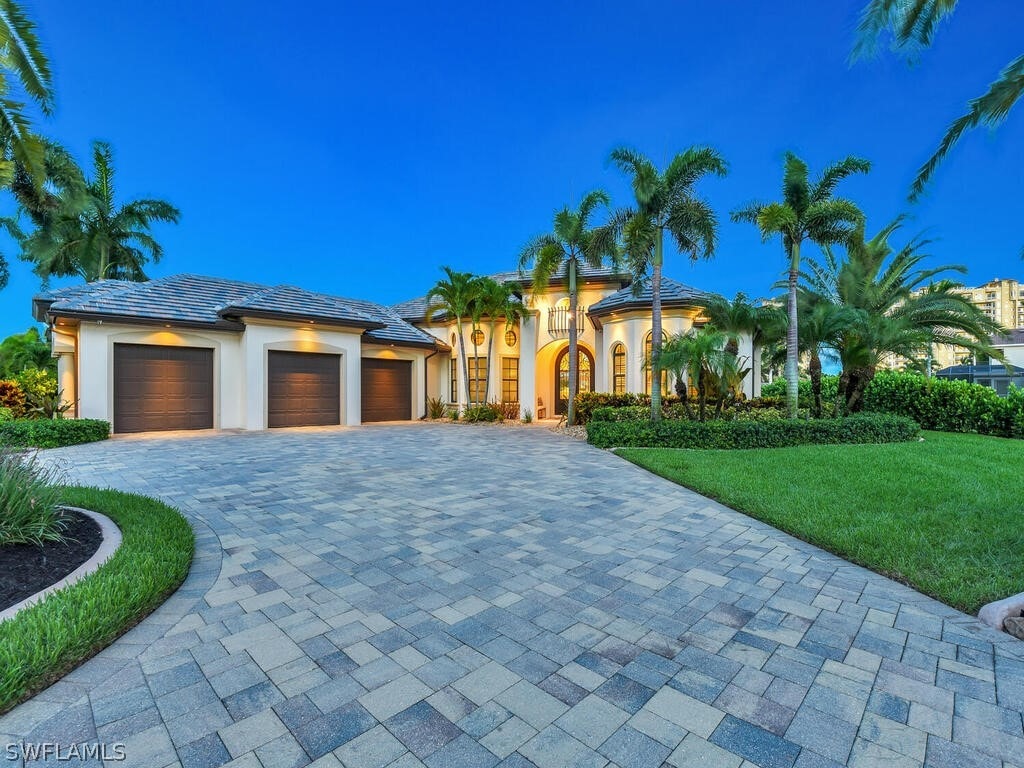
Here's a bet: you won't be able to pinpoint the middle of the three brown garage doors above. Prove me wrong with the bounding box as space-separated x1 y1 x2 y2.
266 352 341 427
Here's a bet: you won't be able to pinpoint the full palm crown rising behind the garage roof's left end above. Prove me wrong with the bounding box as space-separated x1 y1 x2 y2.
22 141 180 283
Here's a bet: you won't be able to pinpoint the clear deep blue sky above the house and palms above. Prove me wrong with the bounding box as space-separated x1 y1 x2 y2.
0 0 1024 336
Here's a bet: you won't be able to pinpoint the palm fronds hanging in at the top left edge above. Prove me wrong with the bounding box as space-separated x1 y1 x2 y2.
0 0 53 288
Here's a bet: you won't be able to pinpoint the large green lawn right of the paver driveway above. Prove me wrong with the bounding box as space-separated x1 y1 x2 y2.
617 432 1024 613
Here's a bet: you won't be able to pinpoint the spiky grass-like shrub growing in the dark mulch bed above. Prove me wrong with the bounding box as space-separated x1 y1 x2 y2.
0 449 65 546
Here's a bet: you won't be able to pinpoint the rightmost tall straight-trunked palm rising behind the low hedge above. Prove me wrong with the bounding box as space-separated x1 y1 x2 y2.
732 153 870 419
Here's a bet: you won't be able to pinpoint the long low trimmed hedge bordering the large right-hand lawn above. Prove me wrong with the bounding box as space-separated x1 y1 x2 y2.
587 414 921 449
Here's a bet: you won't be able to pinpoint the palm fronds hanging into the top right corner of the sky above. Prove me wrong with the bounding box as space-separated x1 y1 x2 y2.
854 0 1024 201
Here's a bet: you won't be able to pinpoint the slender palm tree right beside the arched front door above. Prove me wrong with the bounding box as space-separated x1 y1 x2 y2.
519 189 617 426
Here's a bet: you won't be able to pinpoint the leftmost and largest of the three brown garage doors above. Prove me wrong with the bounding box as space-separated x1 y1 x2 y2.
114 344 213 432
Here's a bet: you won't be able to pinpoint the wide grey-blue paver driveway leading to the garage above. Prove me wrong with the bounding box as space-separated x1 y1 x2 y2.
0 425 1024 768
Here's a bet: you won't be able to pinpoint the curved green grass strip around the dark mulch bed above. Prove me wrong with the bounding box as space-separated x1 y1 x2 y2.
0 487 194 713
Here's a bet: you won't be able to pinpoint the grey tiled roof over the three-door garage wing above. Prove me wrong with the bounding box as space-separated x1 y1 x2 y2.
33 274 444 348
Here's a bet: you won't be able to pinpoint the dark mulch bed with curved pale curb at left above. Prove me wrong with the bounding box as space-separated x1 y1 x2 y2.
0 511 103 610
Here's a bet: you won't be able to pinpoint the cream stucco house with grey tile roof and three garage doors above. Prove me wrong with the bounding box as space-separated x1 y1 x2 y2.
33 267 760 432
